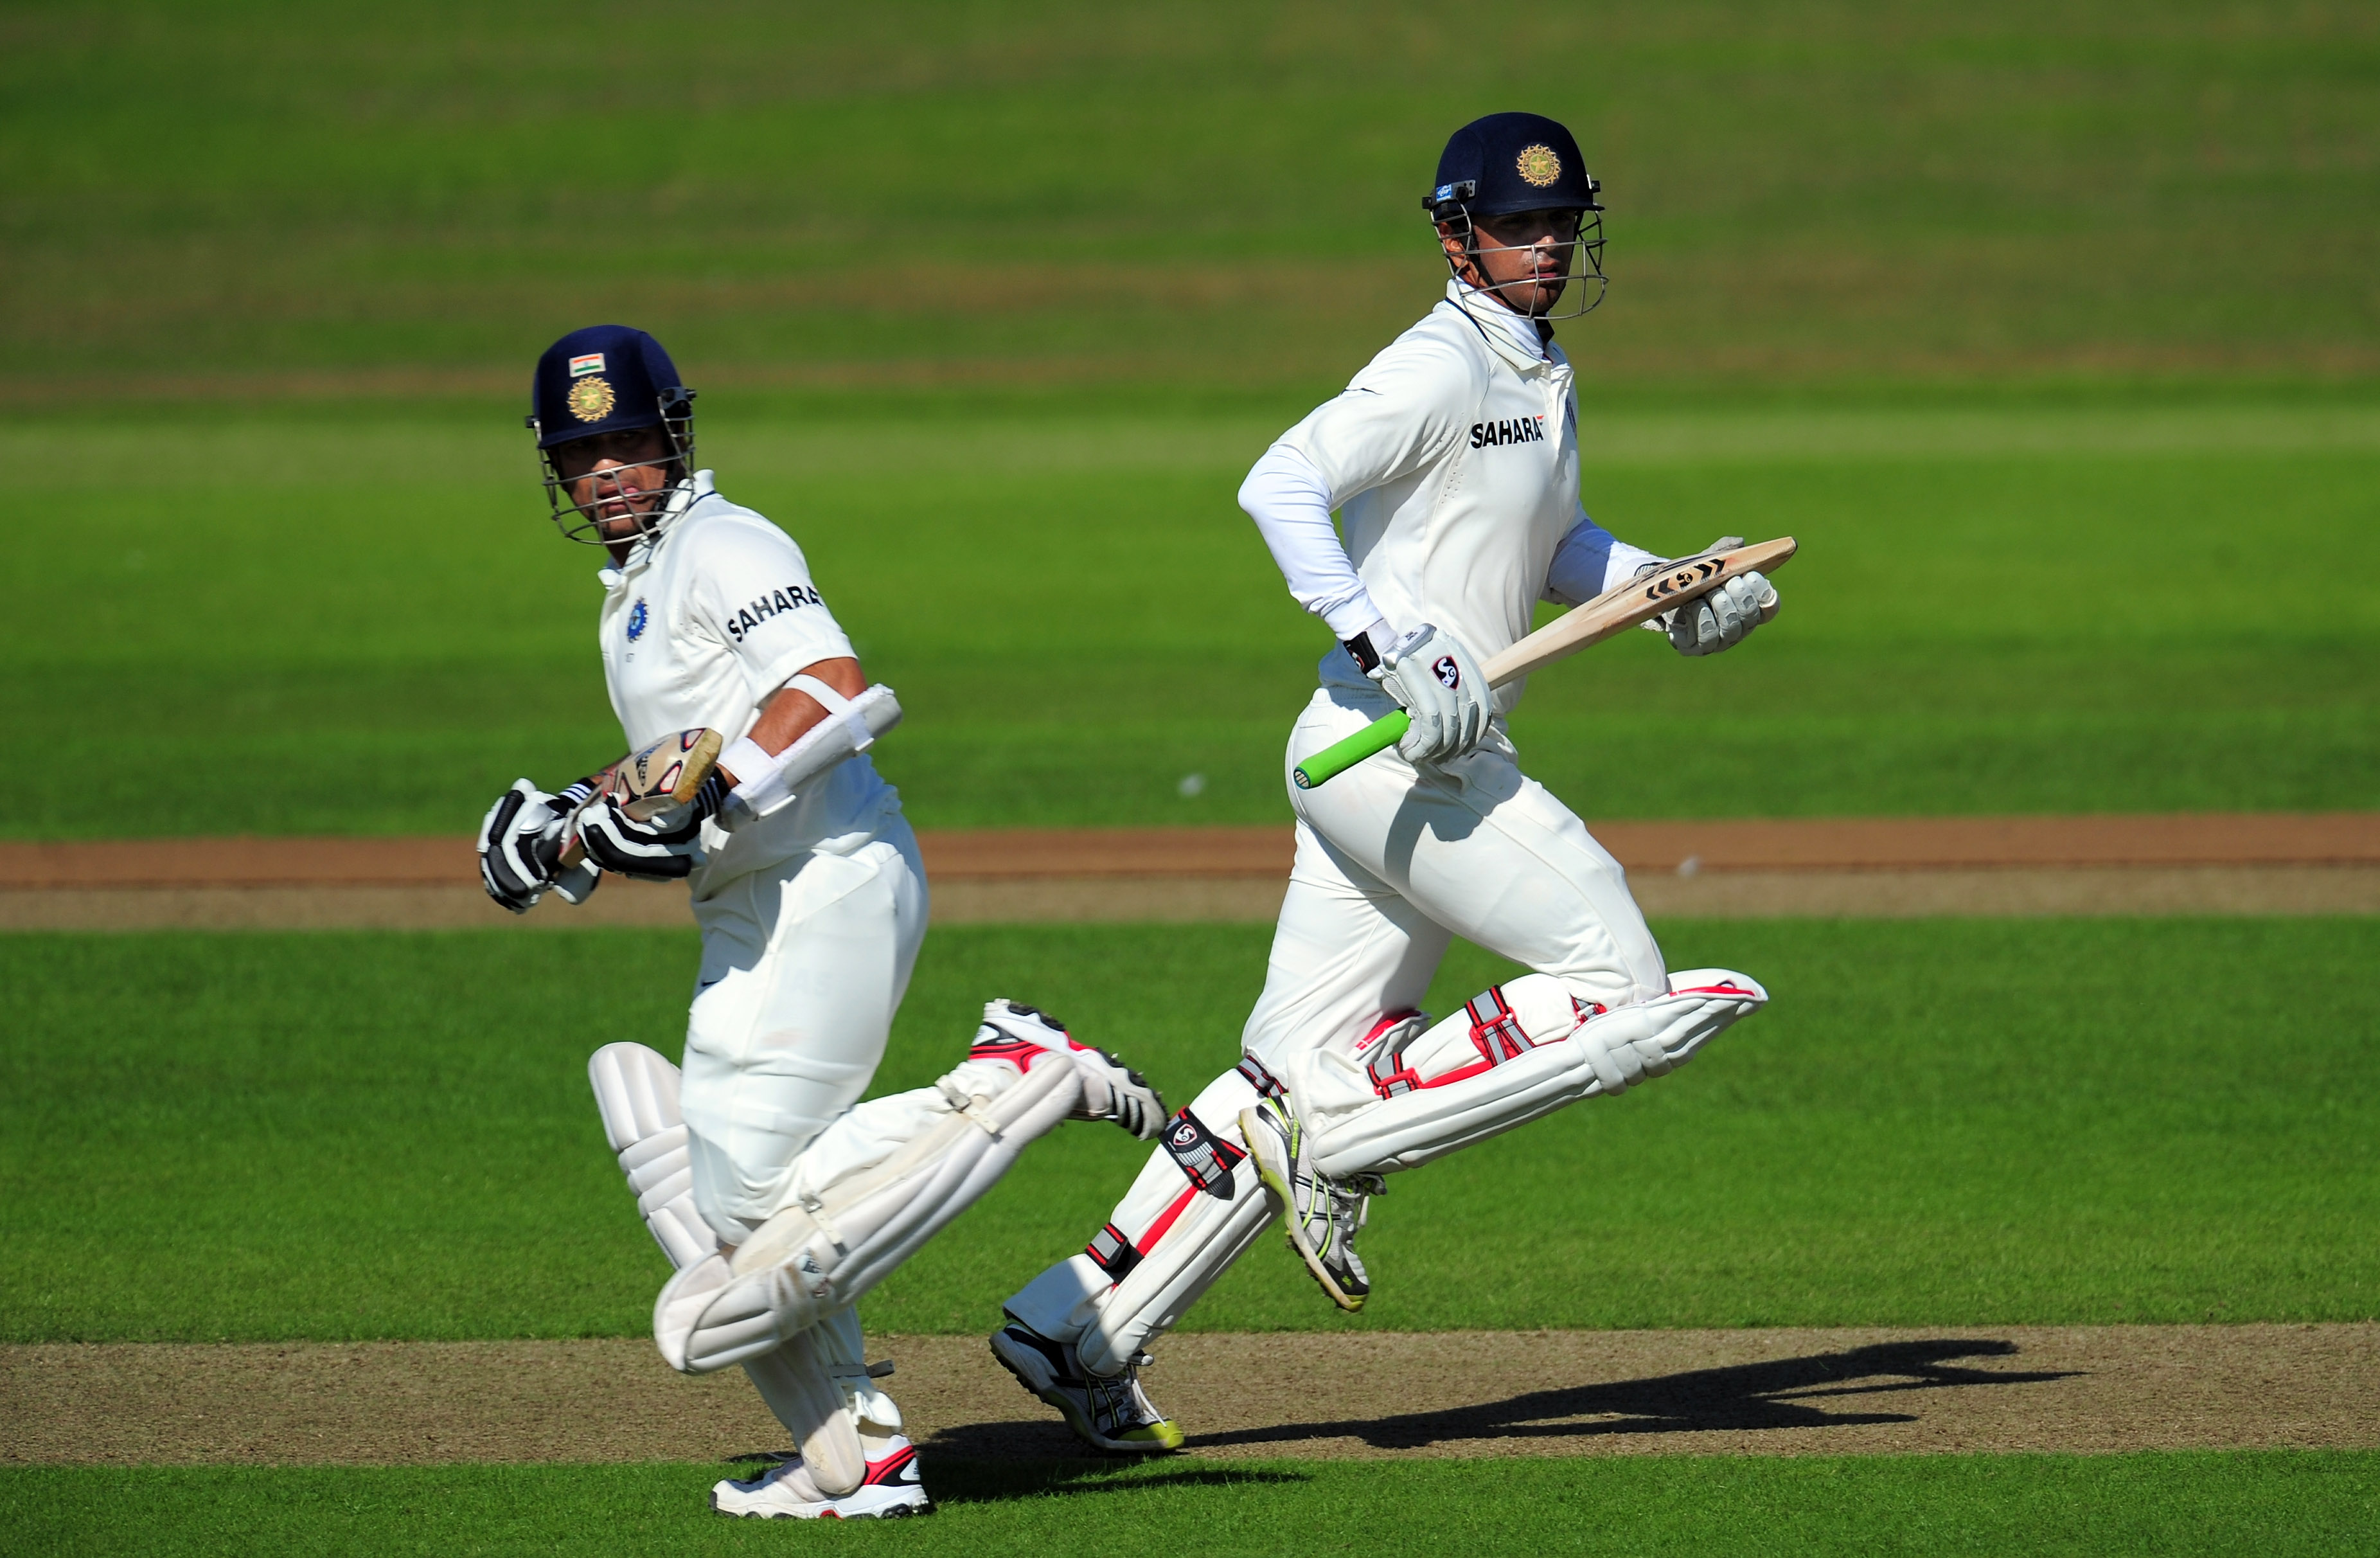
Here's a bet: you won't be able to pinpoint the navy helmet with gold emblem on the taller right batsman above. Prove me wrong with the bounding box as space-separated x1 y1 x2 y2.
1421 114 1606 319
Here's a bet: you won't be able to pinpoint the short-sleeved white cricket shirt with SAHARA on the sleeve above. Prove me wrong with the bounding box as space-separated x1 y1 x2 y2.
598 472 900 898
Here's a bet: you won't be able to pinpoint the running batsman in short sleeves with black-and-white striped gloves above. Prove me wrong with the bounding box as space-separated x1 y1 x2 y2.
481 327 1164 1518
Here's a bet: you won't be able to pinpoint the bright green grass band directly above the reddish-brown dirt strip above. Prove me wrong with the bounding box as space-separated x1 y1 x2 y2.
0 393 2380 839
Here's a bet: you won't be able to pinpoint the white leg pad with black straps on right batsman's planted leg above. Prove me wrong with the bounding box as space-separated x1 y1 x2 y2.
1004 1070 1274 1375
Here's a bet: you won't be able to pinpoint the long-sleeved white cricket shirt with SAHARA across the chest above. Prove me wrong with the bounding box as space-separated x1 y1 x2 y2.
1240 281 1654 712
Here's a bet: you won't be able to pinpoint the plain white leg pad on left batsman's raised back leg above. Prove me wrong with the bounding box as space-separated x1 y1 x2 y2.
652 1051 1083 1375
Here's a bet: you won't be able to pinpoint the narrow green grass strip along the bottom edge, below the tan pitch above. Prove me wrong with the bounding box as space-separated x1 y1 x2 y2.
0 1451 2380 1558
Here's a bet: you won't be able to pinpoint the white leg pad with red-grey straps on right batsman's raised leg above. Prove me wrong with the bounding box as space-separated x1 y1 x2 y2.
1306 970 1768 1179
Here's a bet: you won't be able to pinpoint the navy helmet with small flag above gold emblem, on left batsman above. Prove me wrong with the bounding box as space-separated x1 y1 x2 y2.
528 324 695 546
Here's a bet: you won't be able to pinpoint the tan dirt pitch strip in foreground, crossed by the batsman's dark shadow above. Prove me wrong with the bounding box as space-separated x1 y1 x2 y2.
0 1322 2380 1465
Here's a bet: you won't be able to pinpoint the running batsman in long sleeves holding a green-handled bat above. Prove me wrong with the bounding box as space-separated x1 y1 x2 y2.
993 114 1775 1451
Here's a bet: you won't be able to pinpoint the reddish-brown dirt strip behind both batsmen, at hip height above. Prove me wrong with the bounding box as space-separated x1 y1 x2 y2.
0 812 2380 931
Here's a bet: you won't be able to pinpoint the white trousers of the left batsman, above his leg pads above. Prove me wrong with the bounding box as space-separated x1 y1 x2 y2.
679 812 928 1244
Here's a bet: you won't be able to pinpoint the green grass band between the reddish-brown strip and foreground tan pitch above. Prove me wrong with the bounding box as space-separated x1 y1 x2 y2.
0 920 2380 1341
